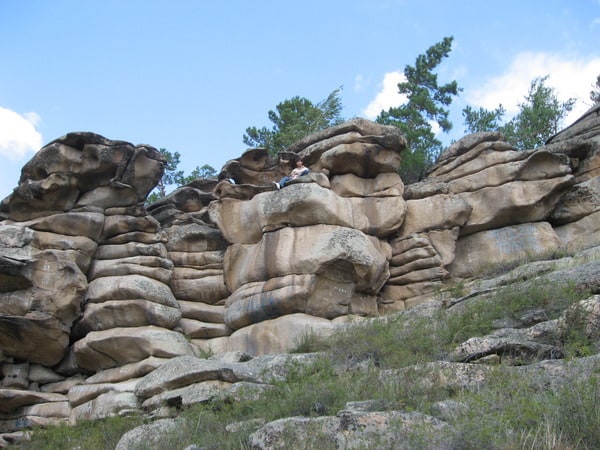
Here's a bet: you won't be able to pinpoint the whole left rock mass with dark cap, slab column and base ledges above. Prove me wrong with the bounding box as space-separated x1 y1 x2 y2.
0 133 193 431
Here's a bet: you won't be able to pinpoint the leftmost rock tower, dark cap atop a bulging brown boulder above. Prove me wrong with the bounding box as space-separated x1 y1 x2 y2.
0 133 164 366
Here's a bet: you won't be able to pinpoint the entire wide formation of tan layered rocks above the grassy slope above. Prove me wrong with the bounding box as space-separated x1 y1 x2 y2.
0 106 600 440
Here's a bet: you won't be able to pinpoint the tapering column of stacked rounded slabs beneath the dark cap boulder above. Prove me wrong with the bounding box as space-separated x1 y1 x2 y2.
73 207 196 372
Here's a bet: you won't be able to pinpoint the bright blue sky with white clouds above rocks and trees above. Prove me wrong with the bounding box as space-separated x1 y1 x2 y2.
0 0 600 199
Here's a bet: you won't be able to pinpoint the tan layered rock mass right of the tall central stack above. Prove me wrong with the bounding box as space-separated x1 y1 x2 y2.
382 106 600 311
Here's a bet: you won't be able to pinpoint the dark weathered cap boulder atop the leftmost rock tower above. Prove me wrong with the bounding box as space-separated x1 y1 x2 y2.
0 133 166 221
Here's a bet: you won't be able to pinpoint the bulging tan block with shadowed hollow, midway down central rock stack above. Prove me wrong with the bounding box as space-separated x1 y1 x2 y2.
224 225 390 329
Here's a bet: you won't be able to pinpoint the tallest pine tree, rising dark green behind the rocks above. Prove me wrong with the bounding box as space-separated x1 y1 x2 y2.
376 37 462 183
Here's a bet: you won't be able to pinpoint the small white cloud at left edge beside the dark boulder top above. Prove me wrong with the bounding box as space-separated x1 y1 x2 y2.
0 107 42 161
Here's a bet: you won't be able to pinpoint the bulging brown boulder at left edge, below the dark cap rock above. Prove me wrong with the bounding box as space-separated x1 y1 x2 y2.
0 224 89 366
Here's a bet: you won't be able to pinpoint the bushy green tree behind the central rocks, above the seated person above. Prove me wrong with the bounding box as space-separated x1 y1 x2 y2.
243 88 343 155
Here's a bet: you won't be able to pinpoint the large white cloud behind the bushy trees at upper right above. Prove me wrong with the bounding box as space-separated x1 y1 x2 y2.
465 52 600 126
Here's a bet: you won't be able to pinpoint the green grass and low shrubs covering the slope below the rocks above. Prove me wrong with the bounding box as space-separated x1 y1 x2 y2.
20 258 600 450
